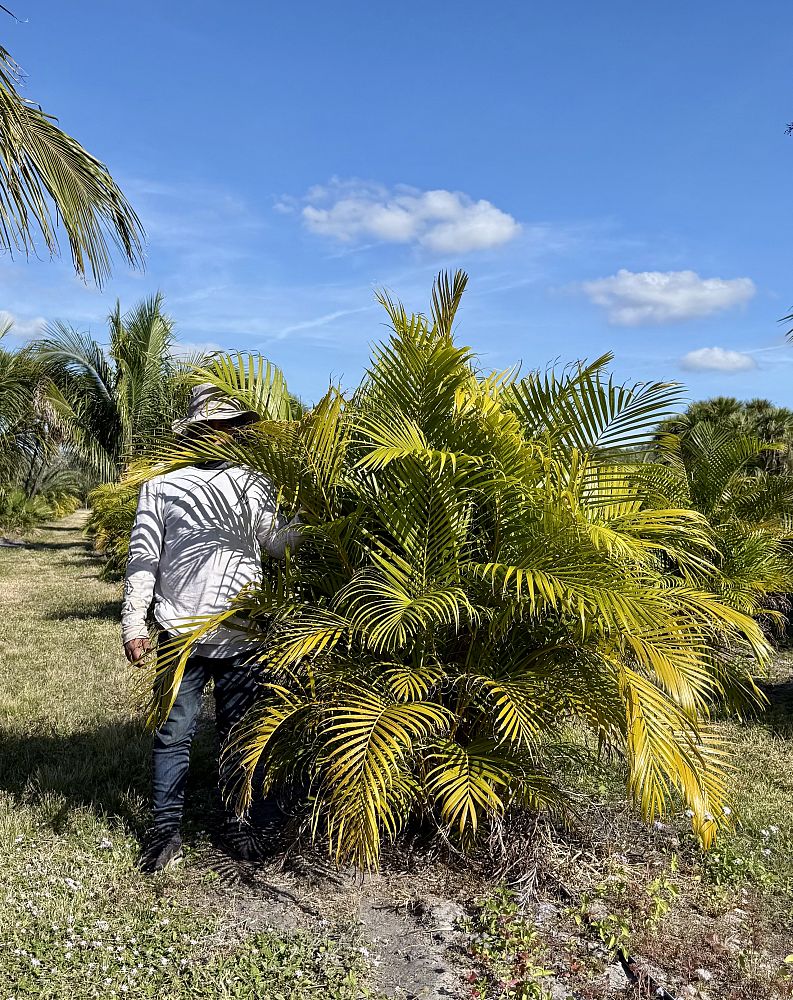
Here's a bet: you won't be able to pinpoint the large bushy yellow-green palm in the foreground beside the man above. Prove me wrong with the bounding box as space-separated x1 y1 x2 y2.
141 273 767 867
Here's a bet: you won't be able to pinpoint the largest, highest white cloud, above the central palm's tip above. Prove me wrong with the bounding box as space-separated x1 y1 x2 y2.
290 180 520 254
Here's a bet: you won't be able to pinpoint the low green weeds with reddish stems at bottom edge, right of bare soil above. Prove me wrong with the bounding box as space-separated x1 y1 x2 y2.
465 889 553 1000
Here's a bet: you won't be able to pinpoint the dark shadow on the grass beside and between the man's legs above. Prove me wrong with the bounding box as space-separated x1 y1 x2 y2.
0 722 217 836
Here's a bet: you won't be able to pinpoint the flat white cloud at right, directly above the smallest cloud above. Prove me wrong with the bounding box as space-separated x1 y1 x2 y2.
582 269 755 326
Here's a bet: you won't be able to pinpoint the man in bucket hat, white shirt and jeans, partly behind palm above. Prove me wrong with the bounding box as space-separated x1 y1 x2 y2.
121 385 297 872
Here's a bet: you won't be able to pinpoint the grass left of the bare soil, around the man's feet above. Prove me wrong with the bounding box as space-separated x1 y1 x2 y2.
0 515 368 1000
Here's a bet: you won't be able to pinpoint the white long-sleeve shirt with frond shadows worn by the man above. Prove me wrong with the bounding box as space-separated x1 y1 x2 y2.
121 466 298 656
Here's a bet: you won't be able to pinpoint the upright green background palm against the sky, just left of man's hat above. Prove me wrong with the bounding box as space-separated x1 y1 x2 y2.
32 295 186 481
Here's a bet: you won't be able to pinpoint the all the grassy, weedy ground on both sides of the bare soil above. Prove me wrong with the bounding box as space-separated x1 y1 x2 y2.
0 516 793 1000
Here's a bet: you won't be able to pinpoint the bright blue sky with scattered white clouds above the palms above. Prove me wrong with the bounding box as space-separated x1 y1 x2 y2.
0 0 793 405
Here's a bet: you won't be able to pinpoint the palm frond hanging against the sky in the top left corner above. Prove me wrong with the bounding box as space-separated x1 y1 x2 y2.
0 46 143 284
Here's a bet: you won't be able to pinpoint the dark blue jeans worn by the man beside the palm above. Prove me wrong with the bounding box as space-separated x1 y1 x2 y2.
152 636 256 827
